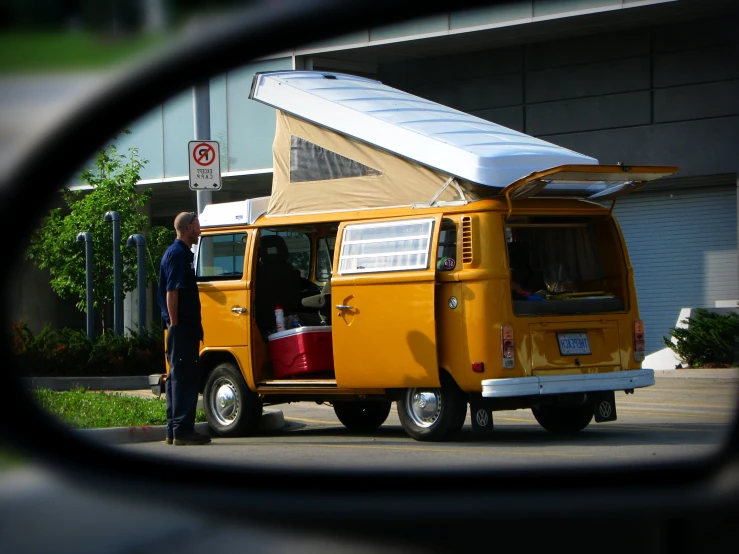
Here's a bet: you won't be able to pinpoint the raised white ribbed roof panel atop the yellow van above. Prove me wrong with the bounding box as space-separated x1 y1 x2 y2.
249 71 598 187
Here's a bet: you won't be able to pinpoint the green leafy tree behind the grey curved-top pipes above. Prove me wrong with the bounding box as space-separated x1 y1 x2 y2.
27 131 175 329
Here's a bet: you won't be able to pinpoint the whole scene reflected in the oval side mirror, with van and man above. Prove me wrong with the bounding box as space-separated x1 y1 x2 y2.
3 2 739 469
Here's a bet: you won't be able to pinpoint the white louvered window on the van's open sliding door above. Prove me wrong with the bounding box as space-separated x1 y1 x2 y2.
339 219 434 275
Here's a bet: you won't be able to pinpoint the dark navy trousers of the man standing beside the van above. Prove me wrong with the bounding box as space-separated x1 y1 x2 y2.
165 325 201 438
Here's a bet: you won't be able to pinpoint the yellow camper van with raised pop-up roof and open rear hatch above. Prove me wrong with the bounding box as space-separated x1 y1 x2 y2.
153 71 677 441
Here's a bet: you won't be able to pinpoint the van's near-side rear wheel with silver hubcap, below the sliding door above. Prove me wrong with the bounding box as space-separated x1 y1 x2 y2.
398 377 468 442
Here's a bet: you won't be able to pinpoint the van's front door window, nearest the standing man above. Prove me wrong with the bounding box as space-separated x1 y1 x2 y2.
195 233 246 281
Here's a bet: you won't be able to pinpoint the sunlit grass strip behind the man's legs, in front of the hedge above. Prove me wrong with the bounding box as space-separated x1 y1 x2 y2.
33 389 205 429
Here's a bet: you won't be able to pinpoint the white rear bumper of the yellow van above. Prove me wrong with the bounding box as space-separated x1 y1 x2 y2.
482 369 654 398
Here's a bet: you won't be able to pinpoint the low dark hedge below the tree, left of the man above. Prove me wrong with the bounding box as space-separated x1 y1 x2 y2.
12 320 165 377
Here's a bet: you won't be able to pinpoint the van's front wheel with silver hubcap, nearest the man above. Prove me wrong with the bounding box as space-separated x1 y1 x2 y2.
203 363 262 437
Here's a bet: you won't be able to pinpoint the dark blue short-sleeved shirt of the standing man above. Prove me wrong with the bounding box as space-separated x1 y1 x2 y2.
157 239 203 340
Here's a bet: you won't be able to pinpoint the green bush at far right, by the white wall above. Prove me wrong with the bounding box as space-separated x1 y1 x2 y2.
662 309 739 367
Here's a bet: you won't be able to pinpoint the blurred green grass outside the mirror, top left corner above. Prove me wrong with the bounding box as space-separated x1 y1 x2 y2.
0 32 169 73
